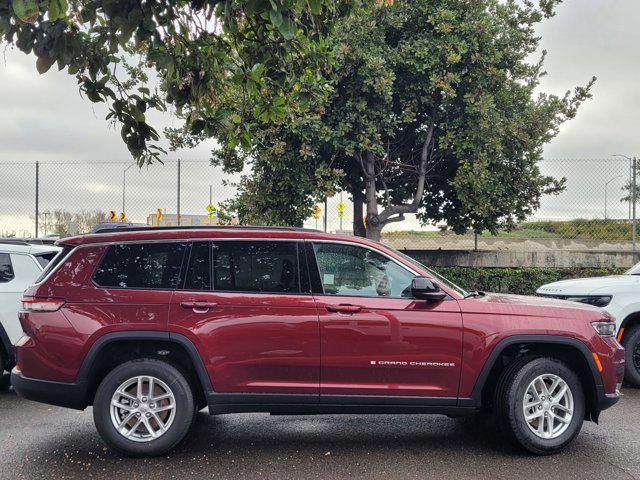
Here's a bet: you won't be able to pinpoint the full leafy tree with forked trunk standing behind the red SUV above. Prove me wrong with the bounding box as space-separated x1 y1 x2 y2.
215 0 595 239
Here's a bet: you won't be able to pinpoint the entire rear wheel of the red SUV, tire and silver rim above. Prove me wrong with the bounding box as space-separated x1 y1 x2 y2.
93 359 195 457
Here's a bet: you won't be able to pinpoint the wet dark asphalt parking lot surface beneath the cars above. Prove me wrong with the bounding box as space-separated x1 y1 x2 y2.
0 376 640 480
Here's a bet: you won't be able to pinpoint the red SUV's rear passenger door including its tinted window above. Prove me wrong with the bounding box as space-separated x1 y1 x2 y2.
170 239 320 403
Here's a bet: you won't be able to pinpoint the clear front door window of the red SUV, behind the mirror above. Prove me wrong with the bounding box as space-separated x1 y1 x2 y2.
313 243 415 297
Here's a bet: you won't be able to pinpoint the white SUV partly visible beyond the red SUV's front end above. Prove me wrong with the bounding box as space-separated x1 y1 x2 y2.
536 263 640 387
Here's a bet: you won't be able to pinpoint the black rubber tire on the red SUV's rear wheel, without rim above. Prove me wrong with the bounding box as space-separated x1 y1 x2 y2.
93 358 196 457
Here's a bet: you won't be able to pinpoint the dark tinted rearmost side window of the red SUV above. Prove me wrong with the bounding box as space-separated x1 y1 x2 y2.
93 243 186 290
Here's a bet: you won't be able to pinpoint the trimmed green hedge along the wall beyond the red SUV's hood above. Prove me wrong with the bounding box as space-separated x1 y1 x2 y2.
436 267 627 295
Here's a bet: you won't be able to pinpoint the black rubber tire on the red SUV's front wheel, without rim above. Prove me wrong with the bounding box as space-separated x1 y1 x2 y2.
494 357 585 455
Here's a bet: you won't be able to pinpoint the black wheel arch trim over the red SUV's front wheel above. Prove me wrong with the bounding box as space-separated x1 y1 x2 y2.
468 335 603 420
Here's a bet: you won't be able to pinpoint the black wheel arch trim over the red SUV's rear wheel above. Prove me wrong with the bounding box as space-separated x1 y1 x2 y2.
76 330 213 405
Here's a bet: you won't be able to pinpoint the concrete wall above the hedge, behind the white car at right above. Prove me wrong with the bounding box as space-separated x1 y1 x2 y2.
401 249 640 268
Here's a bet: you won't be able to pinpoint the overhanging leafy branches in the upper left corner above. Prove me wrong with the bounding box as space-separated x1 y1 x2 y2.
0 0 359 164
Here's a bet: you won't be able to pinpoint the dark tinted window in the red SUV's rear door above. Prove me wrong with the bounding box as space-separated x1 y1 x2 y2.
213 241 300 293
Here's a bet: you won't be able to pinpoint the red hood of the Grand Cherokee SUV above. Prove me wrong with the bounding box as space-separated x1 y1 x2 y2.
460 293 609 320
